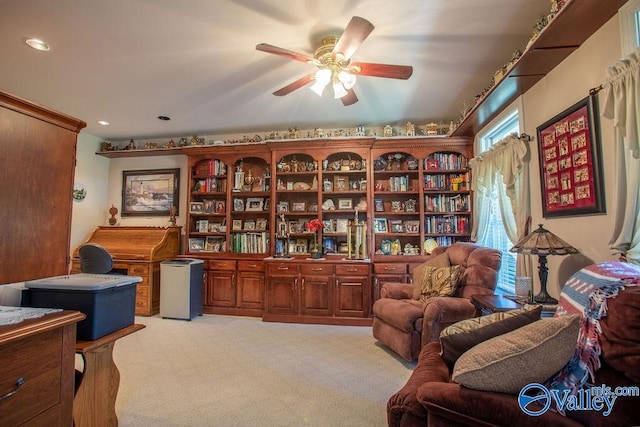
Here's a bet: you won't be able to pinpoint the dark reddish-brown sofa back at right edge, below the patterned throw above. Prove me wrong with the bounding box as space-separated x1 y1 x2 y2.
596 287 640 382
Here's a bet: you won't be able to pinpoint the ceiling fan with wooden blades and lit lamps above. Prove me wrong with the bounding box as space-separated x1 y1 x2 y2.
256 16 413 106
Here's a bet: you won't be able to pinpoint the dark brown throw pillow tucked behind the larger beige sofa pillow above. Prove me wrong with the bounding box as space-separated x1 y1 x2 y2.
440 305 542 368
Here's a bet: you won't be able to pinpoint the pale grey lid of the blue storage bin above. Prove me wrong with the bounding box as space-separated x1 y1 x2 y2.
24 273 142 291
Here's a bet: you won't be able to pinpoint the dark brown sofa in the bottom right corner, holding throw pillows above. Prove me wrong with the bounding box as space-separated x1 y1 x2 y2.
387 264 640 427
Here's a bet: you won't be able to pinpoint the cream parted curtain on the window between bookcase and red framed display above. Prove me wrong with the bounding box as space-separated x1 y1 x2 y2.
469 134 531 275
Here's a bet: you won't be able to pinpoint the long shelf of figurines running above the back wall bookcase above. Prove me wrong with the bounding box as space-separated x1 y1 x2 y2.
96 122 460 158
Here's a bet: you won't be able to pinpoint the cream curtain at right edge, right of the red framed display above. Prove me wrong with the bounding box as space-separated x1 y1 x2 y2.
601 49 640 262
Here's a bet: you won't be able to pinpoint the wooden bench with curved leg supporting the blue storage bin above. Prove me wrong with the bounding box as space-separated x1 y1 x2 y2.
73 324 145 427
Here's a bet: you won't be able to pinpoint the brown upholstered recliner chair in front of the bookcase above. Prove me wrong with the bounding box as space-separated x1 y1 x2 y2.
373 243 501 361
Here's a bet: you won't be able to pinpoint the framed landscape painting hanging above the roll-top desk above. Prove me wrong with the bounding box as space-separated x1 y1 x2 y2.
122 168 180 216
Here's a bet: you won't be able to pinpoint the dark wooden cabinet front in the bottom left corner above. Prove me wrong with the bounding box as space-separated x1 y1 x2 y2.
0 329 62 425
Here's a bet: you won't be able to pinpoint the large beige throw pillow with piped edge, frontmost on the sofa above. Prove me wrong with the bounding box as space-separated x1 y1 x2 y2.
451 315 580 394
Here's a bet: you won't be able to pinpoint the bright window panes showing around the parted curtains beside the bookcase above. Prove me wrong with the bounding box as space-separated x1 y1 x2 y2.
478 108 520 294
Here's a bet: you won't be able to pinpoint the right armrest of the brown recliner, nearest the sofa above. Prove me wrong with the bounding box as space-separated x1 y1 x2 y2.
422 297 476 344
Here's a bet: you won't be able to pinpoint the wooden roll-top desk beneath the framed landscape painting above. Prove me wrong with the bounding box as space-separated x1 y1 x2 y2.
71 226 181 316
